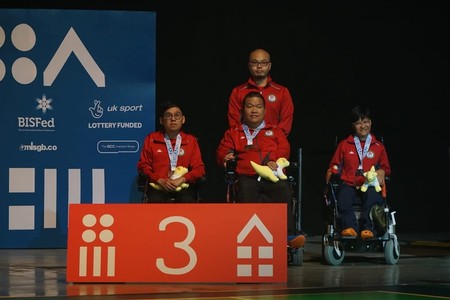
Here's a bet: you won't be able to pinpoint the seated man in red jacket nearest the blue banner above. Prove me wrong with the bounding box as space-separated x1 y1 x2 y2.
137 102 205 203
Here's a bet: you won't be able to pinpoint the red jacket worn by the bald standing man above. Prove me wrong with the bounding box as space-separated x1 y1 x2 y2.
228 76 294 135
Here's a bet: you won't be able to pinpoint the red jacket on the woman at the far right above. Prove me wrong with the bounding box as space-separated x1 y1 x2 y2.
329 134 391 186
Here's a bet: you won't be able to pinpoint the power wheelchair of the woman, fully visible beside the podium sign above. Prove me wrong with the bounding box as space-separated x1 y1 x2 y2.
322 176 400 266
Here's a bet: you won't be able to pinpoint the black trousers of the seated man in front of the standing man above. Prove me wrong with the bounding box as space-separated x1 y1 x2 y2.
236 175 297 235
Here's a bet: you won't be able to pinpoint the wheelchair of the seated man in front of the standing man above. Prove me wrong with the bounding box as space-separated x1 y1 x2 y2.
225 155 306 266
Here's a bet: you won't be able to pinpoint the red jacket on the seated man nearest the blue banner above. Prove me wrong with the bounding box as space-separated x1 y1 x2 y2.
137 131 205 183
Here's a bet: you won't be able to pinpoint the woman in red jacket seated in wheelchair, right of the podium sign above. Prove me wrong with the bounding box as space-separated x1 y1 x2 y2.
326 106 391 239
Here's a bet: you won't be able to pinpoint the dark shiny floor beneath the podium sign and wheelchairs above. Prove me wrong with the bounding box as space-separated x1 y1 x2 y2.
0 233 450 300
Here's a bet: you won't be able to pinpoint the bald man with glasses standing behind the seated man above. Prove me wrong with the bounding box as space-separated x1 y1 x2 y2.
228 49 294 136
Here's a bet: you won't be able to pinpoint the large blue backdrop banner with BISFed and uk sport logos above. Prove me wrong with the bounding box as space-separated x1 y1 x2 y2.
0 9 156 248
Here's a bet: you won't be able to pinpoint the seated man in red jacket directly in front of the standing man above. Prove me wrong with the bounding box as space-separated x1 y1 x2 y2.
216 91 305 248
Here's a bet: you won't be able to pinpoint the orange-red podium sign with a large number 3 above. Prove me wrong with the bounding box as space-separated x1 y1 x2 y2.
66 203 287 283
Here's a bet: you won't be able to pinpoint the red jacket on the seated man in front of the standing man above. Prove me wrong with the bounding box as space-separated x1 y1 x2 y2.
216 123 290 176
